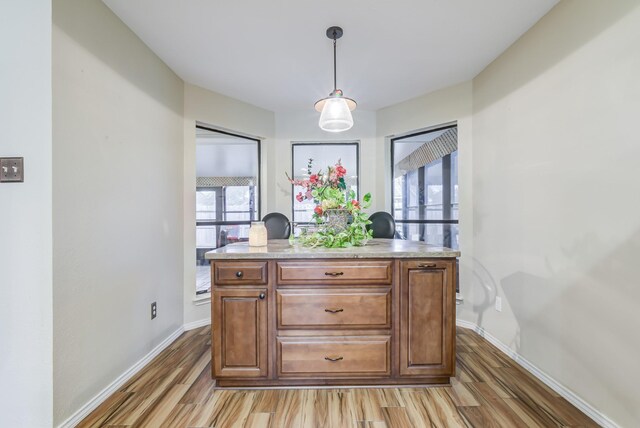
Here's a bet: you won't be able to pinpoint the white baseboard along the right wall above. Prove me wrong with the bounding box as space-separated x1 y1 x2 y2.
456 319 620 428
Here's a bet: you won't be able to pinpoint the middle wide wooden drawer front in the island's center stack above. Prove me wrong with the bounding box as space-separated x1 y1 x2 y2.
277 288 391 329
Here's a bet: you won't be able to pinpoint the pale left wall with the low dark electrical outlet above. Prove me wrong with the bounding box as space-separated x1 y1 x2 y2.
52 0 183 424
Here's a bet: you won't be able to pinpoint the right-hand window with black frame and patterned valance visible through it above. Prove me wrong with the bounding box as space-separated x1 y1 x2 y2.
391 126 459 249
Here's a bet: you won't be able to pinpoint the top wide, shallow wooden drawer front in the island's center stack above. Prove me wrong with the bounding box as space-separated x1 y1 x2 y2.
277 260 392 285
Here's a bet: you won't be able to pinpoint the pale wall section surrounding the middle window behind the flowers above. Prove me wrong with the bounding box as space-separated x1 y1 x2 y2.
272 110 383 218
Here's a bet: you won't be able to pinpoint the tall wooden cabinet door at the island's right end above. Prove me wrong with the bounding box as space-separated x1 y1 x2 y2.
400 260 455 376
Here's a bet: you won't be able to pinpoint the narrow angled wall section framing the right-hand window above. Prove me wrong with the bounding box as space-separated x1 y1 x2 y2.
377 82 474 318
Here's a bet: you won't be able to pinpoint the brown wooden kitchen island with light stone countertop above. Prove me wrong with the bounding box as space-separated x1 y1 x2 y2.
206 239 460 387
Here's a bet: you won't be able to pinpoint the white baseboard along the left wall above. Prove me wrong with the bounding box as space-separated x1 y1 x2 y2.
58 326 185 428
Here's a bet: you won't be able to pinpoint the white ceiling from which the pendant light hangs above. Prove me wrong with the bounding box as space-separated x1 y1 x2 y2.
103 0 558 112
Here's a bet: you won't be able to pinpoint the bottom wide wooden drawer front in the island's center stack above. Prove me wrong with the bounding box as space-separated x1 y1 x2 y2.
278 336 391 377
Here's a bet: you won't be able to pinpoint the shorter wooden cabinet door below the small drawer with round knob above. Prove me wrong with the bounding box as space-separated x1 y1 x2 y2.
211 289 268 378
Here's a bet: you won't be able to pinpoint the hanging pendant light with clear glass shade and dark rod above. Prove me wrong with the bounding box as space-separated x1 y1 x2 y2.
315 27 356 132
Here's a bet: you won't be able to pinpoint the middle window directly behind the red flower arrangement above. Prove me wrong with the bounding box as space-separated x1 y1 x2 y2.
291 142 360 223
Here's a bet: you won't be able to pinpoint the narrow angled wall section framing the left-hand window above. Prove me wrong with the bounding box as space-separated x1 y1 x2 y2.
182 83 275 324
